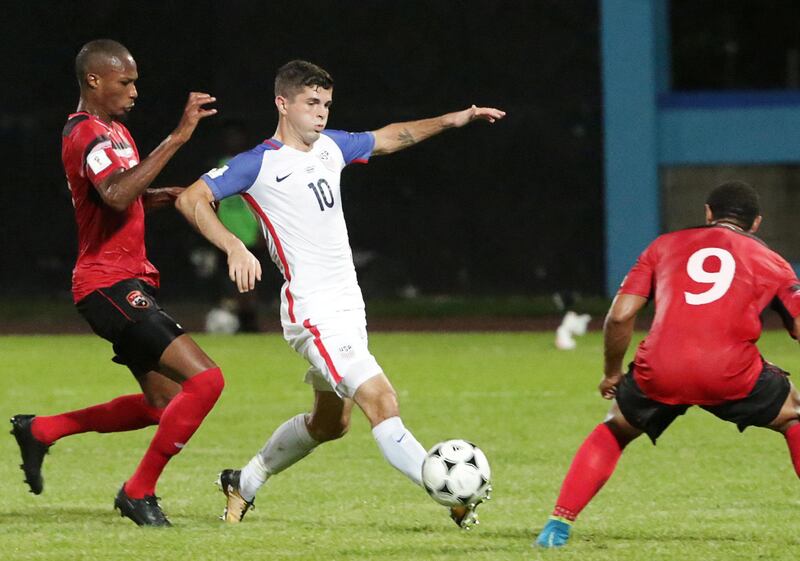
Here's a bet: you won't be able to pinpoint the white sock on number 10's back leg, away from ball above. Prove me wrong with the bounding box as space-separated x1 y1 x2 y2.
239 413 319 501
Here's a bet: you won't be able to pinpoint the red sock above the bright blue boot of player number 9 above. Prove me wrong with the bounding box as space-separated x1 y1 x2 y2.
553 423 622 520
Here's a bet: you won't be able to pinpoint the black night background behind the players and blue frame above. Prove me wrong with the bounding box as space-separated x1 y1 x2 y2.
0 0 796 306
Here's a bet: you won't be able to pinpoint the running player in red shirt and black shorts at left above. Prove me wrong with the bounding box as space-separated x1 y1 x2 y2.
11 39 224 526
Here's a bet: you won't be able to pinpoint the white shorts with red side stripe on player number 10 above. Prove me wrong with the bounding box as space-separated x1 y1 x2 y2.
283 312 383 398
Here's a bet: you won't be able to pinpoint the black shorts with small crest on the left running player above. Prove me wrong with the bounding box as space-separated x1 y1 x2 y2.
76 279 184 376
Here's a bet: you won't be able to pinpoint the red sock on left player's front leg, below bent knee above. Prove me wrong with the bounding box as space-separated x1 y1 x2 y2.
125 368 225 499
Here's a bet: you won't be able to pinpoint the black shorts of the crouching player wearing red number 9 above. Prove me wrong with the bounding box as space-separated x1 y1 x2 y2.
617 362 791 444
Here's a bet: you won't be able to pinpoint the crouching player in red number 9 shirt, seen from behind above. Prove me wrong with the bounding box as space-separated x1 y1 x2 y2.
536 182 800 547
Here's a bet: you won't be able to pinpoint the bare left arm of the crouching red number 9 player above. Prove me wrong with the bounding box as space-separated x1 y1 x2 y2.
598 294 647 399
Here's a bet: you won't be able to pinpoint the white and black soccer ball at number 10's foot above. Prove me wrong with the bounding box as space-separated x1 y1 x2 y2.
422 440 492 506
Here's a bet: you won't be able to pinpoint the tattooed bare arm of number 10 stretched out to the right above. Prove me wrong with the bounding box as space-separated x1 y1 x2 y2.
372 105 506 156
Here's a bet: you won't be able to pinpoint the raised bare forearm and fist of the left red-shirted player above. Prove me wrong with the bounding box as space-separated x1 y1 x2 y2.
97 92 217 212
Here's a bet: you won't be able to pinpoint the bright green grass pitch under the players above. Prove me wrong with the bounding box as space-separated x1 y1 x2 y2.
0 332 800 561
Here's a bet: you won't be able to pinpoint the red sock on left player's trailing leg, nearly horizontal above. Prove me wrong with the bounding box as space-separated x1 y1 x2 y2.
31 393 163 445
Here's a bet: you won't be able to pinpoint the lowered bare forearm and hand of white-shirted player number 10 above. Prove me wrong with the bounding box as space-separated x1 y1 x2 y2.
175 179 261 292
